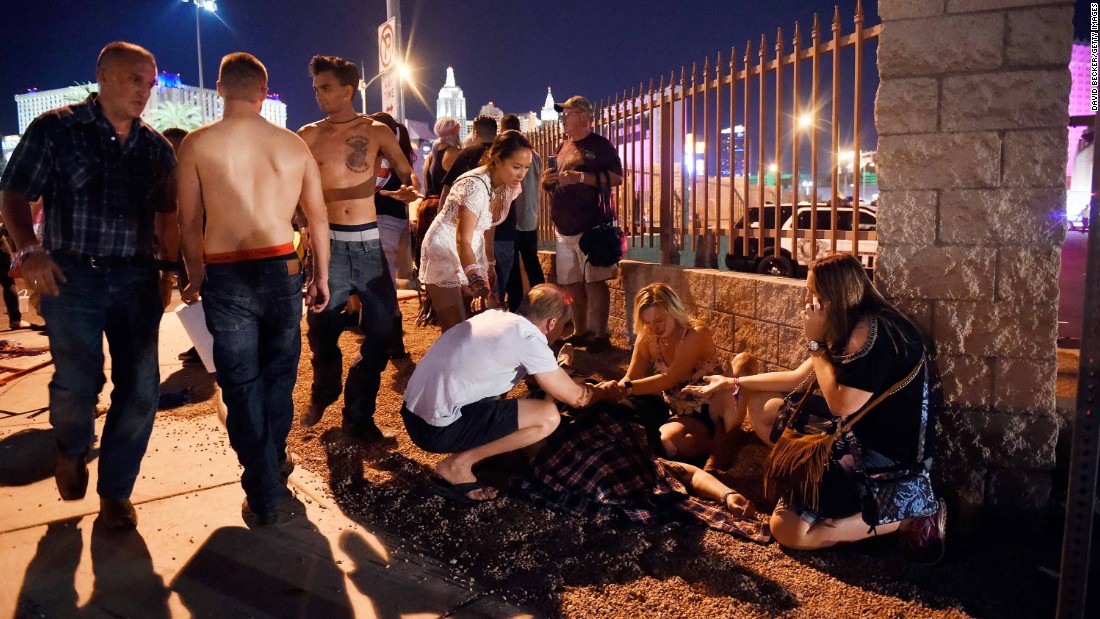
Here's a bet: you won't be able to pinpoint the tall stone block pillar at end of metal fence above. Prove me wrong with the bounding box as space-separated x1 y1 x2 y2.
876 0 1074 517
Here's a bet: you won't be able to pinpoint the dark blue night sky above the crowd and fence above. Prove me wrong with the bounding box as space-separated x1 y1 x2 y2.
0 0 1088 140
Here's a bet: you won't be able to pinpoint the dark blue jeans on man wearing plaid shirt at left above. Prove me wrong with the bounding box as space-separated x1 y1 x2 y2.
42 253 164 499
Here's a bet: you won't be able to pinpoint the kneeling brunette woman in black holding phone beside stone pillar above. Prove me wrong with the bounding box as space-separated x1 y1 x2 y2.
685 254 945 563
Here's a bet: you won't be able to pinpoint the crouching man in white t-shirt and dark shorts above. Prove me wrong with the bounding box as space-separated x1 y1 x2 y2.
402 284 622 502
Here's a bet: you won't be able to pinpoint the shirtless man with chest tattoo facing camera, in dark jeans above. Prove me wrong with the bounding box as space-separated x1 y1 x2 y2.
298 56 413 442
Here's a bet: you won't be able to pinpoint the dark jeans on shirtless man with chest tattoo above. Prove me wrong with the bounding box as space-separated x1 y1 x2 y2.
306 240 400 434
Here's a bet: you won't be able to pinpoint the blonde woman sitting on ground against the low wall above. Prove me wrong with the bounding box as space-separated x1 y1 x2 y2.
598 283 752 464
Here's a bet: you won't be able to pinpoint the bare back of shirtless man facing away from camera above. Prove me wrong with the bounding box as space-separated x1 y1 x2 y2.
180 115 316 254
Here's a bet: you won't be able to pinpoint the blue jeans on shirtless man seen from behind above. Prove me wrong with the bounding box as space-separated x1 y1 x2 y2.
202 256 301 513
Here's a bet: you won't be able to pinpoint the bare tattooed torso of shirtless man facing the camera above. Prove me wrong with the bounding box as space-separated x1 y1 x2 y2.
298 117 409 225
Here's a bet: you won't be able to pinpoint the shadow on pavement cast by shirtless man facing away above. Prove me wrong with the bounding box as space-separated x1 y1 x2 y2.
172 498 355 619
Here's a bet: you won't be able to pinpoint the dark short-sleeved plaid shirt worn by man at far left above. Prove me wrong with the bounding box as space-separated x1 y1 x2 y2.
0 93 176 256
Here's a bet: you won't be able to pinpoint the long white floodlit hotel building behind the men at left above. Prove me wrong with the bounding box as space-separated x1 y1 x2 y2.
15 71 286 134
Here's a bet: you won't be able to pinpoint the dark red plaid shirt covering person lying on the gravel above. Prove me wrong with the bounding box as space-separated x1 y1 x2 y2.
518 413 771 543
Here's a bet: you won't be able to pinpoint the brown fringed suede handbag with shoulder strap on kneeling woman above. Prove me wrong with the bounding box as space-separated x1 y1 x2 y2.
763 355 924 509
